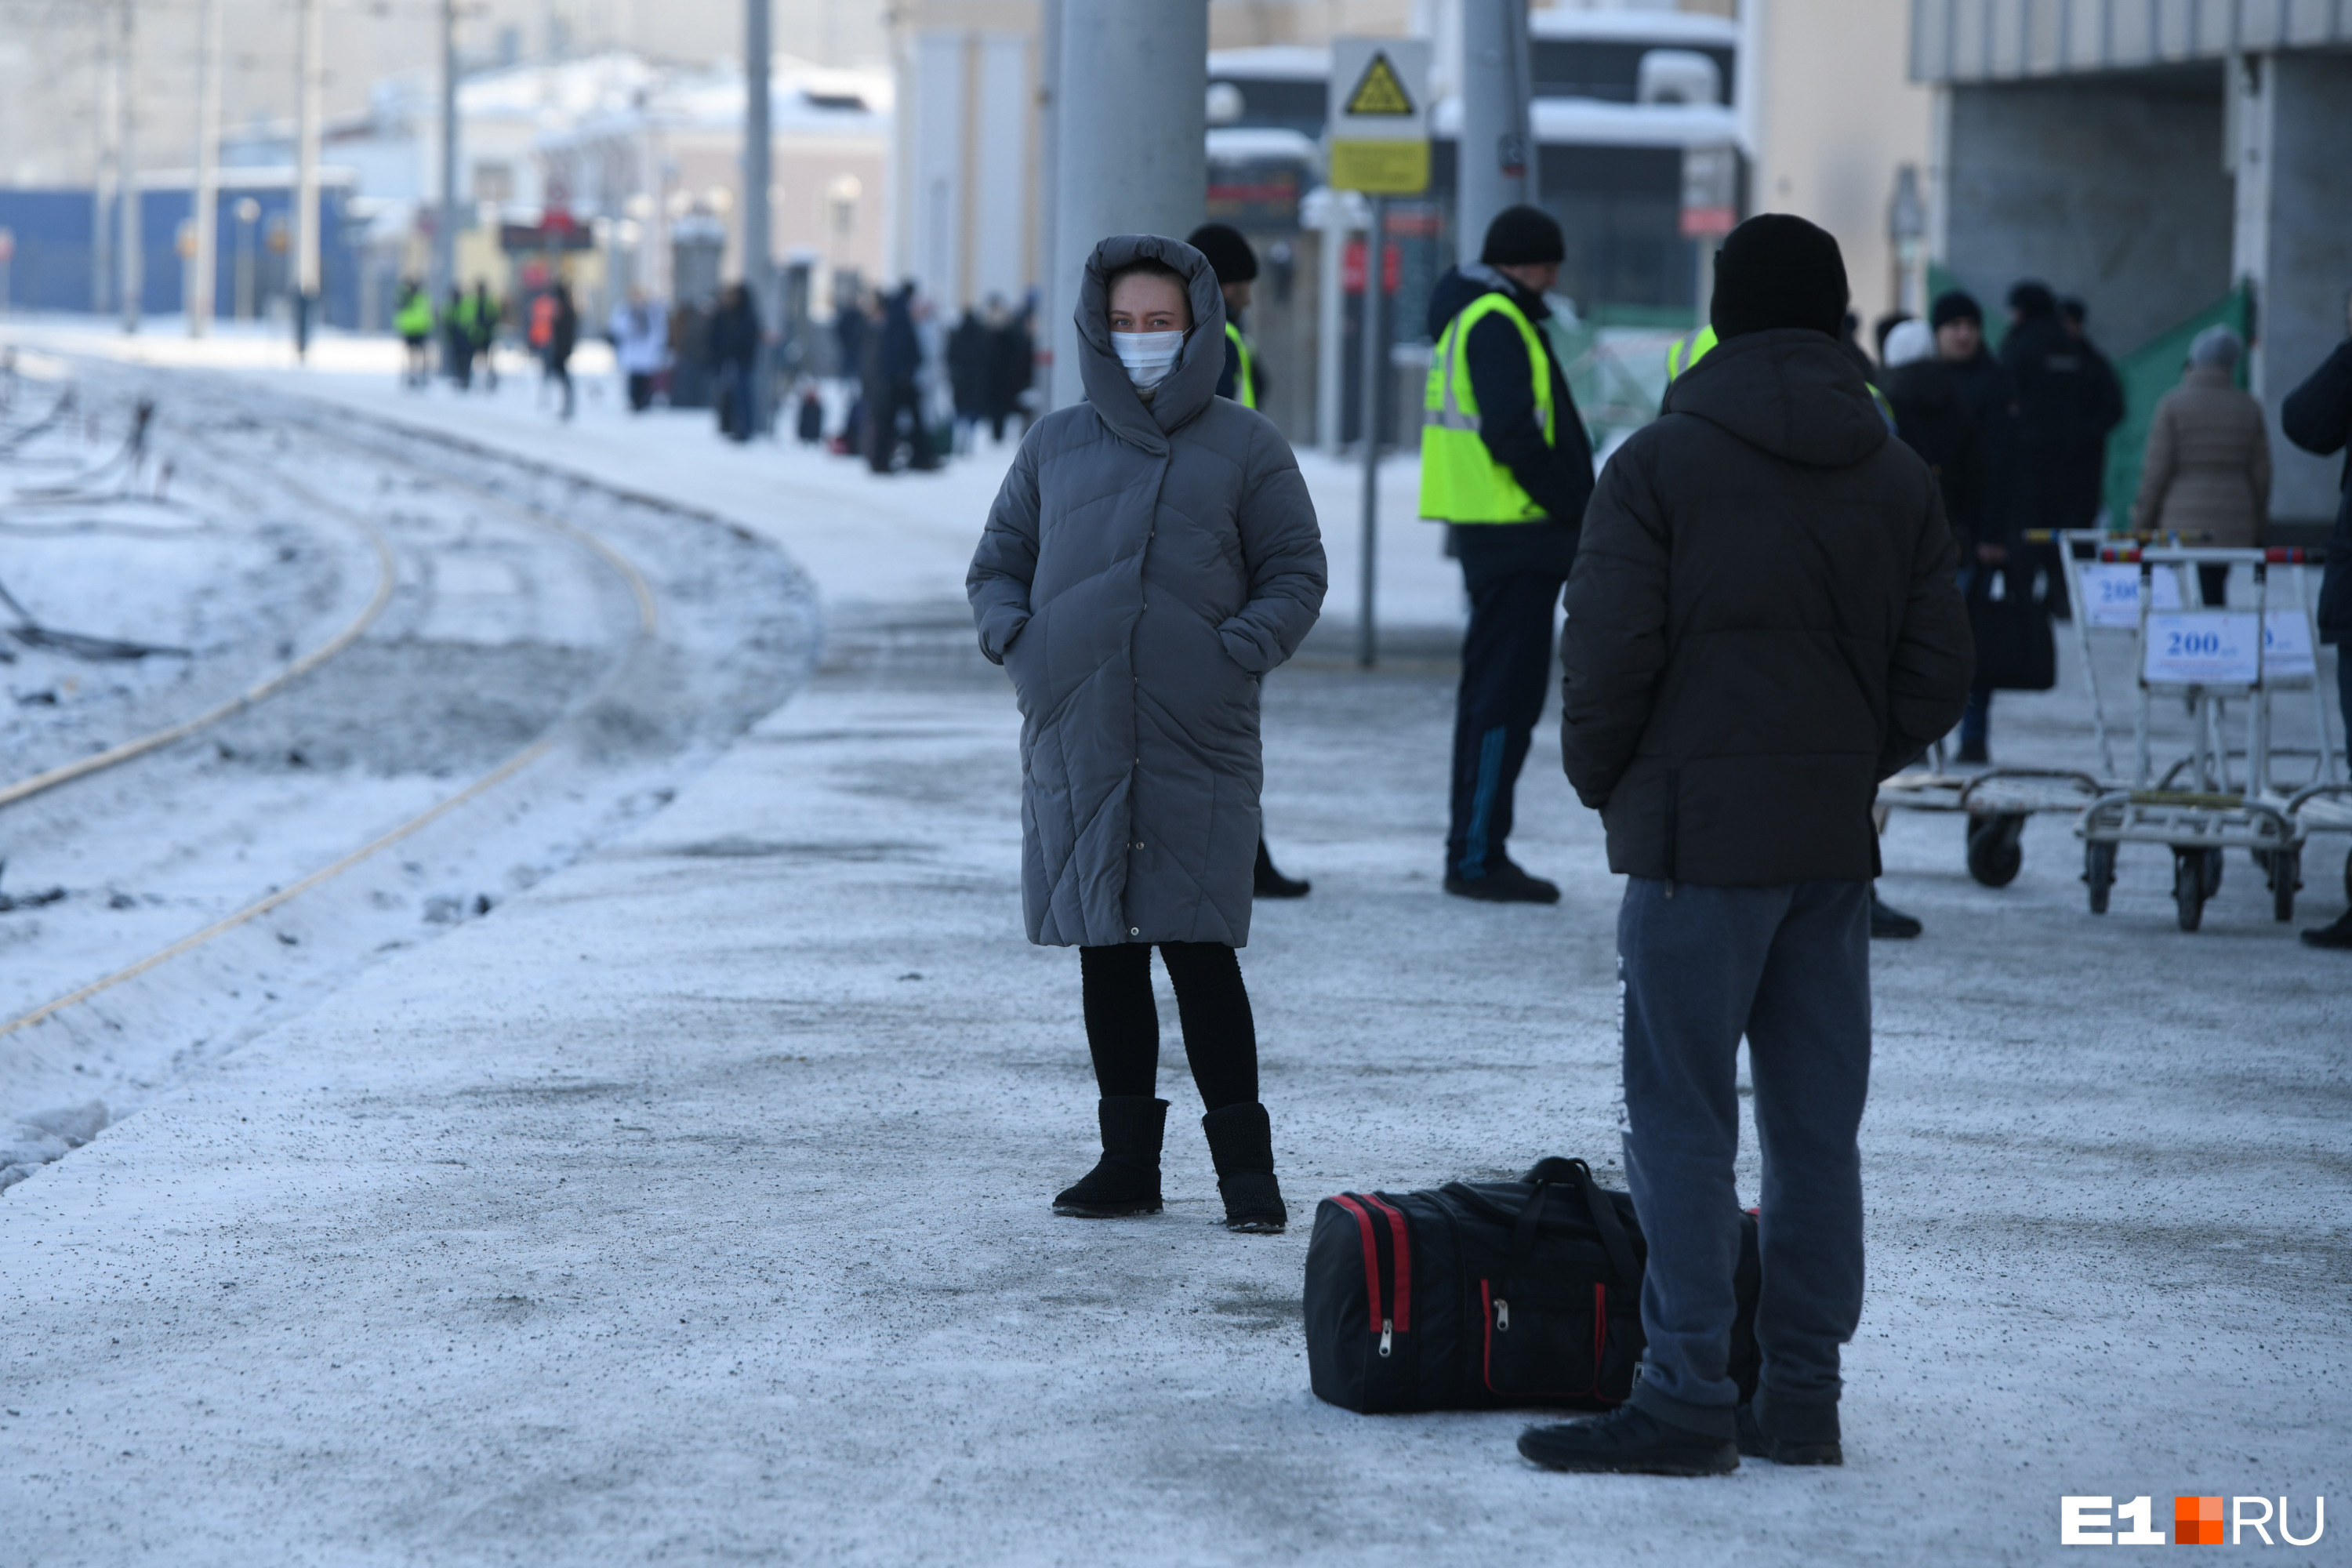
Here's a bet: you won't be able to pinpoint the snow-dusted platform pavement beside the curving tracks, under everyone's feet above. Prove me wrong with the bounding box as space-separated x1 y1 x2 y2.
0 321 2352 1566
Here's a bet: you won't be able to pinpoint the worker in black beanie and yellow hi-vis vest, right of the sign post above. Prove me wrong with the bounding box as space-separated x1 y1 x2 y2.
1421 207 1592 902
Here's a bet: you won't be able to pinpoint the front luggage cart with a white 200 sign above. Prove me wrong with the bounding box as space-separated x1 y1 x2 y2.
2074 543 2296 931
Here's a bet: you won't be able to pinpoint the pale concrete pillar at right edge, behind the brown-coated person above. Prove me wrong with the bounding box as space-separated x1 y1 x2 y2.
2230 52 2352 524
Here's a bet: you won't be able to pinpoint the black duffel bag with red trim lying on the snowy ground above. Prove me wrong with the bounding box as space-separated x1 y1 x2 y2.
1305 1156 1764 1415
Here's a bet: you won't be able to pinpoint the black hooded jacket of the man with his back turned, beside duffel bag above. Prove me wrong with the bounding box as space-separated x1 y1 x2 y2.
1559 327 1976 886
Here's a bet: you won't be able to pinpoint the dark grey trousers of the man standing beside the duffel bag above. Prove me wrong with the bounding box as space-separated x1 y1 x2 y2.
1618 877 1870 1441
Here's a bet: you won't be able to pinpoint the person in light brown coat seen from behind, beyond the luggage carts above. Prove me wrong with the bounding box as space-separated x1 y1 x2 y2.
2131 327 2270 604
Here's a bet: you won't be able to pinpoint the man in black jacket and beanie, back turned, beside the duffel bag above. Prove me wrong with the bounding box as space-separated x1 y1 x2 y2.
1519 214 1973 1474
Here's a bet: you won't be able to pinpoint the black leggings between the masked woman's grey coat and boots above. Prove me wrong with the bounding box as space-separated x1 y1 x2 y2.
1077 942 1258 1109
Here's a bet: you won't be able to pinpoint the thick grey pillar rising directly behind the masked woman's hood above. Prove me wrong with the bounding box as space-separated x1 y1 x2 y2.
1047 0 1209 409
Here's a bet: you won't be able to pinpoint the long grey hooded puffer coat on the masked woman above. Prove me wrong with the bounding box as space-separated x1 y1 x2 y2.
964 235 1324 947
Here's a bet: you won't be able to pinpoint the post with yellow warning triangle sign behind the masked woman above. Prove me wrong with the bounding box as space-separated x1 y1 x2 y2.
1329 38 1430 670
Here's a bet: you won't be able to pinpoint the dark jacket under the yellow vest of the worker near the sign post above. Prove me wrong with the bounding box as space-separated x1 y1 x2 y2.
1428 266 1592 574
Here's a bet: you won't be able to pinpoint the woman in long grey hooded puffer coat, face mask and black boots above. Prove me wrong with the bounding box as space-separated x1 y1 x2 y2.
964 235 1324 1232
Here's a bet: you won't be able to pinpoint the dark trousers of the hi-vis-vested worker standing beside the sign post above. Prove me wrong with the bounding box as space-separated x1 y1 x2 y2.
1446 562 1569 877
